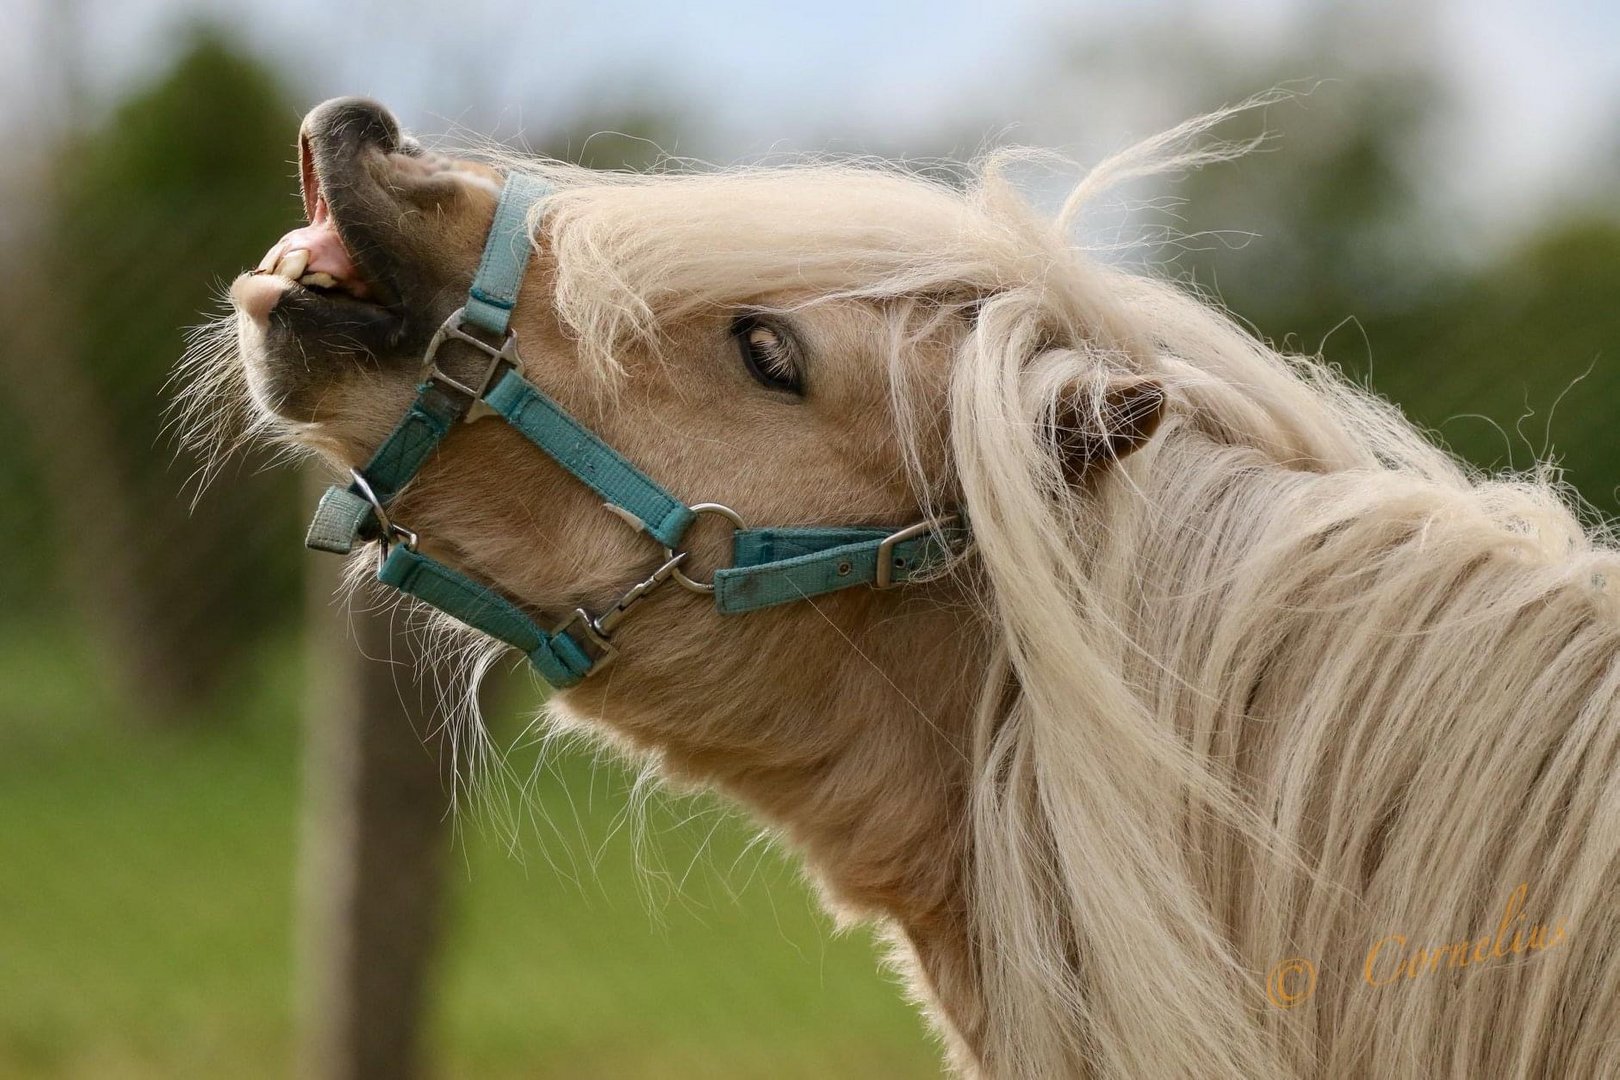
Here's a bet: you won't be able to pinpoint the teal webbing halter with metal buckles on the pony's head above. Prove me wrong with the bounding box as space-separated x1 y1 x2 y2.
305 173 969 688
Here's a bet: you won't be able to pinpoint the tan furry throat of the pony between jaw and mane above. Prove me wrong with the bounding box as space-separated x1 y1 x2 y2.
564 583 991 1062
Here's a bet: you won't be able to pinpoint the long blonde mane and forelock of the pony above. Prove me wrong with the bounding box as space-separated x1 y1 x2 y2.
456 115 1620 1077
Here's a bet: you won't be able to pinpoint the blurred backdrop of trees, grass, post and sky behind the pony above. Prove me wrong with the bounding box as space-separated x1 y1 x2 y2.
0 0 1620 1077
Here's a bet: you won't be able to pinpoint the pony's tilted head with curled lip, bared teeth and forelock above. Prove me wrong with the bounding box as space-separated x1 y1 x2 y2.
196 99 1168 745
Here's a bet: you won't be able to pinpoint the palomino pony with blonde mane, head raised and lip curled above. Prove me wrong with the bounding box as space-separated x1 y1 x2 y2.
183 99 1620 1078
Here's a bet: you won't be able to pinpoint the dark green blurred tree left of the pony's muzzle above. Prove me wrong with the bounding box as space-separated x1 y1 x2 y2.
6 31 298 717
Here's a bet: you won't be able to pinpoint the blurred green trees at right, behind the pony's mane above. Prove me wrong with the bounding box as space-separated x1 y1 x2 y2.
1153 19 1620 513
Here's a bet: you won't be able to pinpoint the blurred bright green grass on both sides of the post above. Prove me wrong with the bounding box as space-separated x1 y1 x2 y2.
0 627 938 1078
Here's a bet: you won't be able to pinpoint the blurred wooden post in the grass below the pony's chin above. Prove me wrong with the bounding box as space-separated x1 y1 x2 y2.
298 476 450 1080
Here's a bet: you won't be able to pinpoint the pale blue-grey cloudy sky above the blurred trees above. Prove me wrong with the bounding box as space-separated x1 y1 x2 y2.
0 0 1620 234
